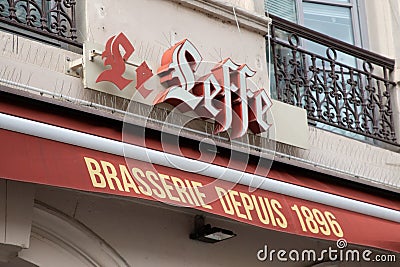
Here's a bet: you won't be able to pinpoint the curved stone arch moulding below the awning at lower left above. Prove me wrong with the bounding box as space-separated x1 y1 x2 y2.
11 203 129 267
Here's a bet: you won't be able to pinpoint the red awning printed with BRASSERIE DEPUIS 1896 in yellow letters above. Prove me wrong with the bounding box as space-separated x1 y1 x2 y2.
0 89 400 252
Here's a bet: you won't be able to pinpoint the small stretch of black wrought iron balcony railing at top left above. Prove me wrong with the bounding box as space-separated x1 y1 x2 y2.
0 0 79 45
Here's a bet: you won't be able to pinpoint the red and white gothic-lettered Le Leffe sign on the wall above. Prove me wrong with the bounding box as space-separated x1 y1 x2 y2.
84 33 272 139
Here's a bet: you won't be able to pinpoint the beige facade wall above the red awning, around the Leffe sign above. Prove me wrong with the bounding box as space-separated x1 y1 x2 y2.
0 0 400 195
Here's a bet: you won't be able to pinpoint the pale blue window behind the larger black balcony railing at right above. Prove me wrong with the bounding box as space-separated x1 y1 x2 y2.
265 0 384 140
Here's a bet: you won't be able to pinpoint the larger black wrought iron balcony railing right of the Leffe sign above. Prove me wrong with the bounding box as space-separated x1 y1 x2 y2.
271 16 397 145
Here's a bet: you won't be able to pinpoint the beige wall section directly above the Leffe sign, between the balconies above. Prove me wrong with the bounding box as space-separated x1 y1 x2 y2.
82 0 268 104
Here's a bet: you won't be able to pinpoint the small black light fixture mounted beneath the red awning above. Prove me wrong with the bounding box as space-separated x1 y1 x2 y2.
190 215 236 243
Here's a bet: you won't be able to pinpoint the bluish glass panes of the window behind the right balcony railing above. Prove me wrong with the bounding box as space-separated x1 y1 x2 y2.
266 0 365 140
